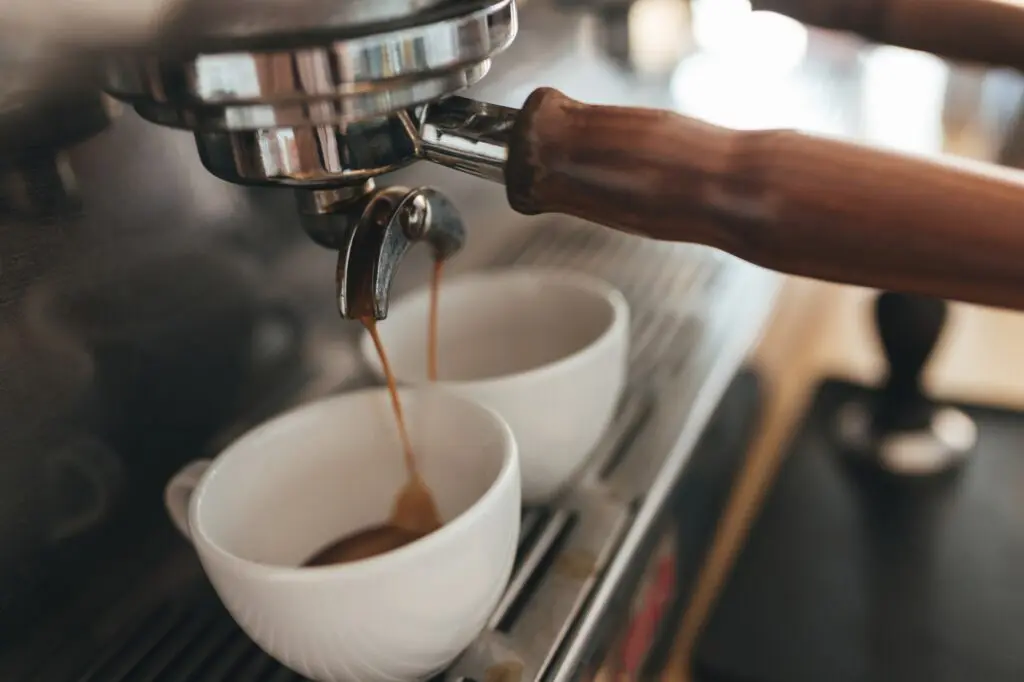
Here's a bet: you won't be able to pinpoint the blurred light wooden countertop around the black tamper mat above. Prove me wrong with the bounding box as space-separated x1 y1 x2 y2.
663 278 1024 682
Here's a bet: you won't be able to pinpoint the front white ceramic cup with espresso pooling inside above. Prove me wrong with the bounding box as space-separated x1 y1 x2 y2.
165 389 520 682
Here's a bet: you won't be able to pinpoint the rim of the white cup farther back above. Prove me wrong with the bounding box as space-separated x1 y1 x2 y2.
359 266 630 388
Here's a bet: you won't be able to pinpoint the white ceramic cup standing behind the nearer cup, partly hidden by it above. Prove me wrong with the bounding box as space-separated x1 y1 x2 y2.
361 267 630 504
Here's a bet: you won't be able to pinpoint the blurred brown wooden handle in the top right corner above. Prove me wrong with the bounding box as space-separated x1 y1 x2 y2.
752 0 1024 71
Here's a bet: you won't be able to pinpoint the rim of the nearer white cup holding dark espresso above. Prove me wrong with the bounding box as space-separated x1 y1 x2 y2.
188 386 519 581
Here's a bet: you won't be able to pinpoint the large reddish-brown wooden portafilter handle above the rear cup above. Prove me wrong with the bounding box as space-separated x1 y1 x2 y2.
506 88 1024 309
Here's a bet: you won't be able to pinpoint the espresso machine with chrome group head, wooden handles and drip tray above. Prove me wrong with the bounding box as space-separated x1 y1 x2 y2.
6 0 1024 682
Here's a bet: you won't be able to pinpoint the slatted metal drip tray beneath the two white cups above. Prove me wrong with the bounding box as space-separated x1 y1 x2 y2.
19 218 768 682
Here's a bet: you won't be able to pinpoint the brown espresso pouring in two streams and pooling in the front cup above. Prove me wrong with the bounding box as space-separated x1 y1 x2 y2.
304 260 443 566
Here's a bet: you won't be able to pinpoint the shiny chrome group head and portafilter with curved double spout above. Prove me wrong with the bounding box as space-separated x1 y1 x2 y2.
96 0 517 318
